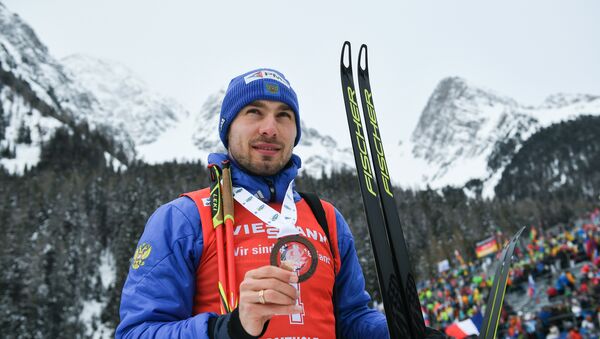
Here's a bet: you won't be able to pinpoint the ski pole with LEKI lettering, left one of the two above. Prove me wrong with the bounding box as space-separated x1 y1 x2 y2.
208 164 231 314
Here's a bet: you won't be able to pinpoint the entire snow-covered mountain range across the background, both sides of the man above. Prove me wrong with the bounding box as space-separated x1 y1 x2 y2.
0 4 600 196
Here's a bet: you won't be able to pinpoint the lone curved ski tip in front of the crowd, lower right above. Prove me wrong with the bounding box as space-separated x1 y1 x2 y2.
479 227 525 339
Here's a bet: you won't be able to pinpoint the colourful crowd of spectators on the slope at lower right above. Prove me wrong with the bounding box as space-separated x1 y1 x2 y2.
419 209 600 338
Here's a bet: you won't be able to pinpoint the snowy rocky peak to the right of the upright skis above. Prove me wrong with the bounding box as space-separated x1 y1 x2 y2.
390 77 600 196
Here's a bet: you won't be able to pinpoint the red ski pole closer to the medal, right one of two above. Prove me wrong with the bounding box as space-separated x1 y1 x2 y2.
221 160 238 310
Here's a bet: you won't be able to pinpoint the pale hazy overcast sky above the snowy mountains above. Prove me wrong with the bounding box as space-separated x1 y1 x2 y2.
0 0 600 145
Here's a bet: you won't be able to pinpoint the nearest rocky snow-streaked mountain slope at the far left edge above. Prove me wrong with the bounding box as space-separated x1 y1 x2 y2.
0 3 134 172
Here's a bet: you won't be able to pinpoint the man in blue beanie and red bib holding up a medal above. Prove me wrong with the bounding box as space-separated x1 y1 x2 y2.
116 69 389 339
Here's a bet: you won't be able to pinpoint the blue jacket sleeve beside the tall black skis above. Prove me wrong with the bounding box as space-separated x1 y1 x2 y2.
335 209 389 339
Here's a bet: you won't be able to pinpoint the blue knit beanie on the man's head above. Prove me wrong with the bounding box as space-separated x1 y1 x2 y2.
219 68 300 148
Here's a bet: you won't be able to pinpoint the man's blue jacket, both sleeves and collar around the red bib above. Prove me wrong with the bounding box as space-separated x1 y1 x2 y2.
116 154 389 338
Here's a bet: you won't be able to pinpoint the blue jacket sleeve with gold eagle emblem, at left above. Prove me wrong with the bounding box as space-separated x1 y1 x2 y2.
115 197 229 338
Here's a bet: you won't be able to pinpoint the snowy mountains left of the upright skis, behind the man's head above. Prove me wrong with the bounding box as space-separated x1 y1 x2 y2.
0 4 353 175
